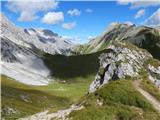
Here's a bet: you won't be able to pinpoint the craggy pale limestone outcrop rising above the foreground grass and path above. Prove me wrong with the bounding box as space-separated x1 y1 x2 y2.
89 42 160 92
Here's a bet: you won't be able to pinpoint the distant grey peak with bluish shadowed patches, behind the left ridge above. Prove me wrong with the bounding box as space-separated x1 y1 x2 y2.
25 28 73 55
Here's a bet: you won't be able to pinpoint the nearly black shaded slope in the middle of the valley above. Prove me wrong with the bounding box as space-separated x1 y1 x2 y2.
44 50 112 79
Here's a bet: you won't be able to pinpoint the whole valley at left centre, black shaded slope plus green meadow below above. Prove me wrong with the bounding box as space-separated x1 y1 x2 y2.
1 48 112 119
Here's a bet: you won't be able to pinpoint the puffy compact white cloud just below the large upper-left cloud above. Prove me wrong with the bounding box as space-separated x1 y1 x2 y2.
42 12 64 25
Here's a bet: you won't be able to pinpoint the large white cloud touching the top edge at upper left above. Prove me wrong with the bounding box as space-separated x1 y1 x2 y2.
7 0 58 21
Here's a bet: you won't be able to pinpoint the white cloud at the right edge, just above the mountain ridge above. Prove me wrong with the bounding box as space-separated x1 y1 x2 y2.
145 8 160 26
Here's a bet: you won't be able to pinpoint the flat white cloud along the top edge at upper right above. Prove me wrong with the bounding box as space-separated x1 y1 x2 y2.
117 0 160 9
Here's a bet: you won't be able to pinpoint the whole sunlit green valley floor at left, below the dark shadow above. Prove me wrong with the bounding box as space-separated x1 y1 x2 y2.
1 75 94 120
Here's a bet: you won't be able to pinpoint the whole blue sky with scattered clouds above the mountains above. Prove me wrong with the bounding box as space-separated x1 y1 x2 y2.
2 0 160 43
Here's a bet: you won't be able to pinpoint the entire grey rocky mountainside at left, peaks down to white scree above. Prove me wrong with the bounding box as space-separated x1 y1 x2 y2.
0 14 72 85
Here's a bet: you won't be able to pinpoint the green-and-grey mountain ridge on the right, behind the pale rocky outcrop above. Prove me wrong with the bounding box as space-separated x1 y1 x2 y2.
78 23 160 59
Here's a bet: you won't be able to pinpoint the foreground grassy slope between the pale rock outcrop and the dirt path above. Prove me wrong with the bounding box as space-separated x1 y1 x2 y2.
70 80 160 120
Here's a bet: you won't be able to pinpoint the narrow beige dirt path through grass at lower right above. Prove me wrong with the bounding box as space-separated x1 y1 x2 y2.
133 80 160 112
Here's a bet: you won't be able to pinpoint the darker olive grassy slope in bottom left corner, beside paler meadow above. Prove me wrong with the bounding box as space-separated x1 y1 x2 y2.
1 75 70 120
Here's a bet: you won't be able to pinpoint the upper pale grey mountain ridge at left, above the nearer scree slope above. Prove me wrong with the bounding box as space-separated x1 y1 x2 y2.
0 13 72 55
